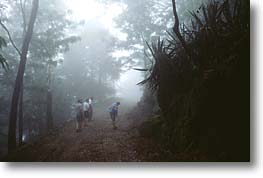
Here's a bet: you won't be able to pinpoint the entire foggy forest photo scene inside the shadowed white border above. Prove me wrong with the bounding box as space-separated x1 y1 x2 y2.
0 0 250 162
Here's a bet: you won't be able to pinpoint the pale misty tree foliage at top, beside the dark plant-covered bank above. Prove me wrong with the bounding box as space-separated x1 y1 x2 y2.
115 0 211 67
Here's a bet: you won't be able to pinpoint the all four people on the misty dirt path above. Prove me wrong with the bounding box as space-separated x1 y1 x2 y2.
75 97 120 132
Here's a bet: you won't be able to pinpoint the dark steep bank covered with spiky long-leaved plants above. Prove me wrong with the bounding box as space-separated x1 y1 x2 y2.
141 0 250 160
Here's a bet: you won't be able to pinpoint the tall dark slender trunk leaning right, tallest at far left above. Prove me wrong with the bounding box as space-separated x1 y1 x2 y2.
8 0 39 152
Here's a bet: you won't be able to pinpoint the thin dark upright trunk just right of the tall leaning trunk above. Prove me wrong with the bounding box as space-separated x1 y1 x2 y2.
18 84 24 146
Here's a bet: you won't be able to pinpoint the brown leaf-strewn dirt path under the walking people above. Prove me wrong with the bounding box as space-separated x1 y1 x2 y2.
5 118 165 162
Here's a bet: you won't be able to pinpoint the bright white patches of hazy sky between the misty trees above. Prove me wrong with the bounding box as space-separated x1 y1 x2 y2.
66 0 143 102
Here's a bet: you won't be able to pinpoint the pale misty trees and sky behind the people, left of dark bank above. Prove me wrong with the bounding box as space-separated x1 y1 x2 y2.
0 0 210 156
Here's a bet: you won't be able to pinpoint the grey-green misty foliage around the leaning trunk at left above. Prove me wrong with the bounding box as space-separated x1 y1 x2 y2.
0 0 80 140
